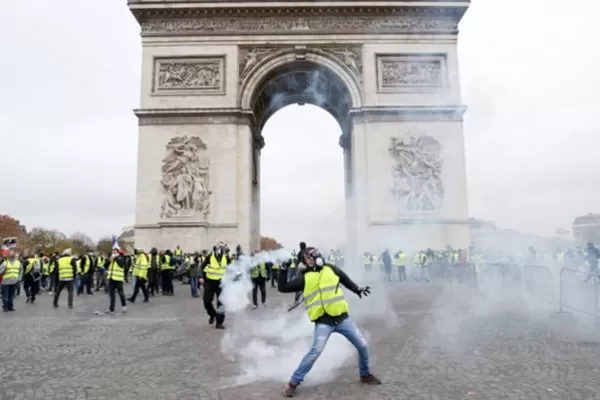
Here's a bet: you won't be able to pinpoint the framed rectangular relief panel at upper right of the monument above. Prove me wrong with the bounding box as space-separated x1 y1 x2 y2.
376 53 448 93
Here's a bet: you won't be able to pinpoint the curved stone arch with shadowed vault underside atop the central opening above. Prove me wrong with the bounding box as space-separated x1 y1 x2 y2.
239 49 363 130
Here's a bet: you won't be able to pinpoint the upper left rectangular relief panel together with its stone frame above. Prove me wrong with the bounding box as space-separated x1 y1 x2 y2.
152 55 226 96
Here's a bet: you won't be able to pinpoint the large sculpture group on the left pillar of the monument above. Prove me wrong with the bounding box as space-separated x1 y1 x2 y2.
160 136 212 218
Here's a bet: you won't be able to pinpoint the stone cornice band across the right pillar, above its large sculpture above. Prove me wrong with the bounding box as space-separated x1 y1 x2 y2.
350 106 467 123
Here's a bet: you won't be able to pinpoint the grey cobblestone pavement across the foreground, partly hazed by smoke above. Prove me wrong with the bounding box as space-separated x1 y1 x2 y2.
0 284 600 400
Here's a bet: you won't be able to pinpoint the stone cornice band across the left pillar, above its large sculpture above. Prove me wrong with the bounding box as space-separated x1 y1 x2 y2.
134 108 254 125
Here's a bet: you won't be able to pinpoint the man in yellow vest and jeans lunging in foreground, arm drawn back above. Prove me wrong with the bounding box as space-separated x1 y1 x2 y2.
278 247 381 397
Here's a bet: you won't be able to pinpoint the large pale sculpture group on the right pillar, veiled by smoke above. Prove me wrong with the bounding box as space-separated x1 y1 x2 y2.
388 136 444 212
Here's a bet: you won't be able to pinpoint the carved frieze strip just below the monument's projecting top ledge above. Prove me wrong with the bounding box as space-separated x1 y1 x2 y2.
140 13 458 36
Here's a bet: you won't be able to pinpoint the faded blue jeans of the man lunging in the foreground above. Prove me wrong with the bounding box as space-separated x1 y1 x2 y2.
290 317 370 385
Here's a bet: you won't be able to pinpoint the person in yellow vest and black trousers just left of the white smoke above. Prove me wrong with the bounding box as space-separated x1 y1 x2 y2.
200 244 231 329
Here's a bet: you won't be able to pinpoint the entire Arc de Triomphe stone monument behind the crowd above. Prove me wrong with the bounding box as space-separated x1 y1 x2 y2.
129 0 469 251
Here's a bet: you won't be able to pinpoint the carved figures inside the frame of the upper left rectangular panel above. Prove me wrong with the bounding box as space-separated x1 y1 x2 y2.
154 58 224 92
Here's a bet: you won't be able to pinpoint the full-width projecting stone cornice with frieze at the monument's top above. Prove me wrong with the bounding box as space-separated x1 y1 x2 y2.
131 3 468 37
